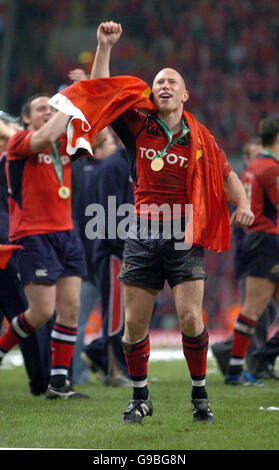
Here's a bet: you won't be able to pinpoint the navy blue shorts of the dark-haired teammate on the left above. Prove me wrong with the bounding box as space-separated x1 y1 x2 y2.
15 230 87 286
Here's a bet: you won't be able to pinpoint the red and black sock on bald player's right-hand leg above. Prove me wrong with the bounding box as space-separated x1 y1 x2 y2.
182 327 208 398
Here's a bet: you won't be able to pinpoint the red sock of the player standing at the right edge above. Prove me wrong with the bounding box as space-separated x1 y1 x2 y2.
228 313 257 375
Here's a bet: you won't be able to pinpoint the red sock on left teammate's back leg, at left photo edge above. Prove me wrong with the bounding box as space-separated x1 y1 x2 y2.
0 313 35 358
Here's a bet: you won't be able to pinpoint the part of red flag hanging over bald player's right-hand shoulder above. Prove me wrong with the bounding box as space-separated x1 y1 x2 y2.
183 111 230 252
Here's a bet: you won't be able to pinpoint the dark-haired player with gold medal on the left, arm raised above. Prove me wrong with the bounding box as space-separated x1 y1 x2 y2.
0 94 86 398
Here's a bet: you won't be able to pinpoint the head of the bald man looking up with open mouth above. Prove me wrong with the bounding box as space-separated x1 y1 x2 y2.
152 68 189 114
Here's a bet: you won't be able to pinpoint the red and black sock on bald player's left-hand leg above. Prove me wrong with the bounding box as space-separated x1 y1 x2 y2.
123 335 150 400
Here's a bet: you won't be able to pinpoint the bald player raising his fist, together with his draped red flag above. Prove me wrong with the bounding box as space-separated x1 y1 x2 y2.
51 22 254 423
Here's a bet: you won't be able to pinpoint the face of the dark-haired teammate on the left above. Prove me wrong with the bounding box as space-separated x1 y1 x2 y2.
24 96 56 131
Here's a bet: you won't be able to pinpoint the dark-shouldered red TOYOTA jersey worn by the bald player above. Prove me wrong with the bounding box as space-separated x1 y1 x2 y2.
112 110 232 216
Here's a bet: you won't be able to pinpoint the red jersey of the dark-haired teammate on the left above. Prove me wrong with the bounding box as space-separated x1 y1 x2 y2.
6 130 73 241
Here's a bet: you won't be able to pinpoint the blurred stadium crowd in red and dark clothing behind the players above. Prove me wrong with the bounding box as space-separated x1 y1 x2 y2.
0 0 279 328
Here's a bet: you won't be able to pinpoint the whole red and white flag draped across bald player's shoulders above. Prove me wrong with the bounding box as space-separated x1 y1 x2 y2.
49 76 230 252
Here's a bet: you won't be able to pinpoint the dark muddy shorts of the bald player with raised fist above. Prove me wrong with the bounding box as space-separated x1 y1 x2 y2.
118 217 206 290
